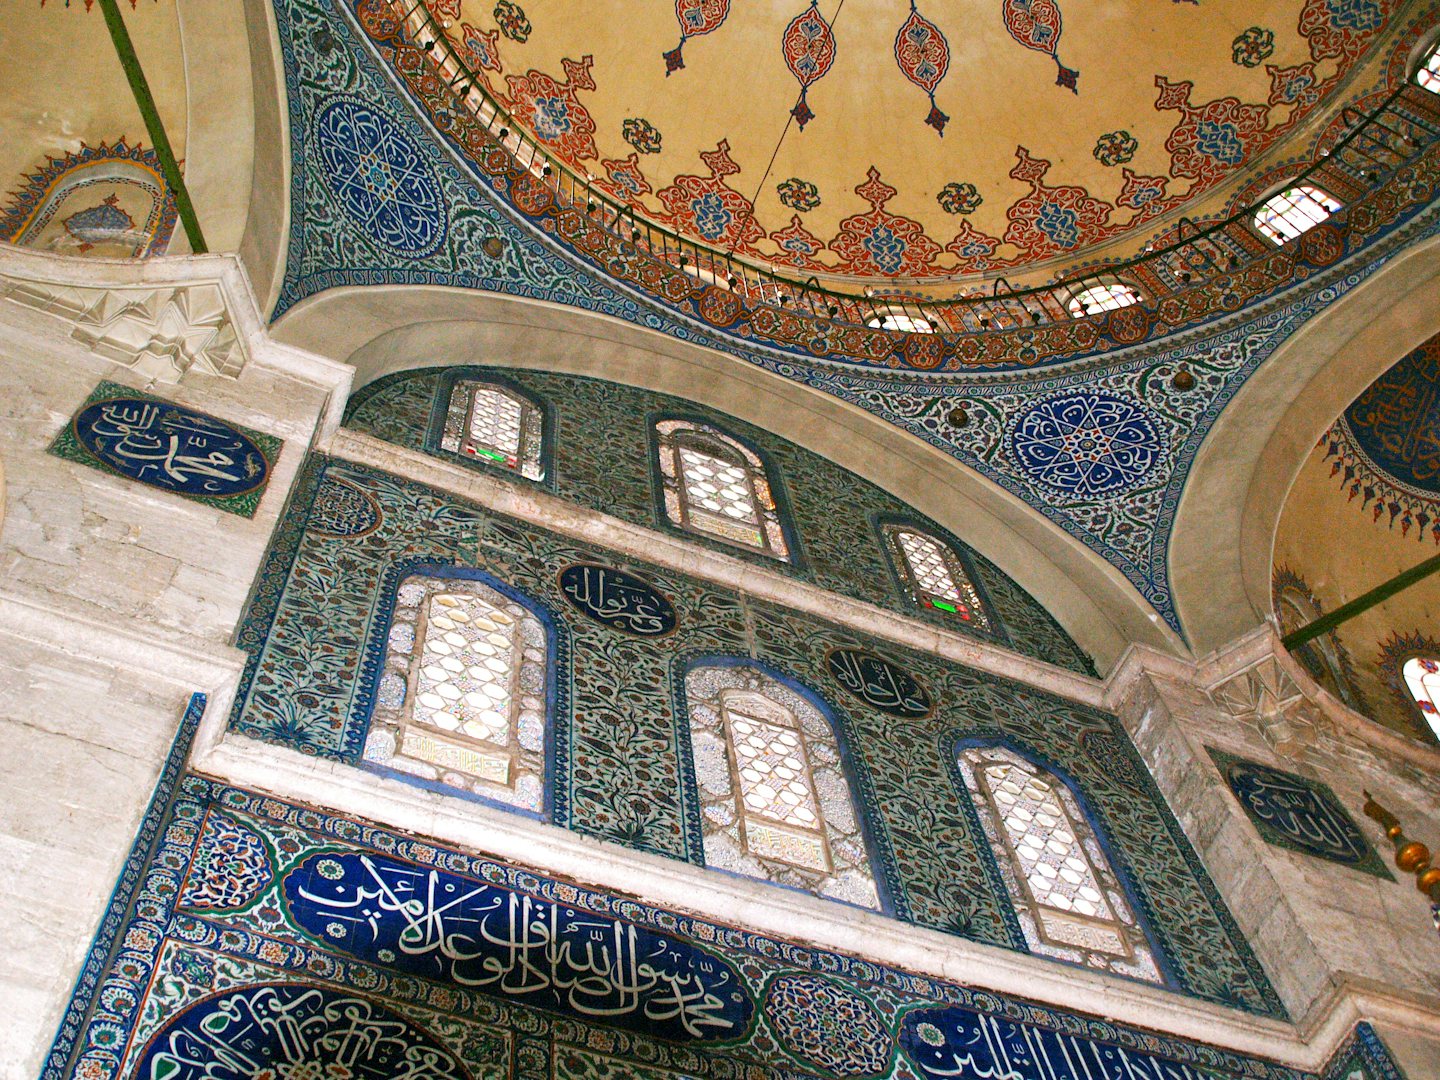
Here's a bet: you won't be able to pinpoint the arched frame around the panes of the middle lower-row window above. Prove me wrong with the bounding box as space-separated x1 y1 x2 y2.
671 652 909 919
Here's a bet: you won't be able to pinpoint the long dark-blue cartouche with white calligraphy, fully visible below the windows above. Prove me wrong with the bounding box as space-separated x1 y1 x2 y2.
284 854 755 1043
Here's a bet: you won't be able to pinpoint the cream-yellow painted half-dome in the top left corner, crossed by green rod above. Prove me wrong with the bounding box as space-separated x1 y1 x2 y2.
0 0 187 259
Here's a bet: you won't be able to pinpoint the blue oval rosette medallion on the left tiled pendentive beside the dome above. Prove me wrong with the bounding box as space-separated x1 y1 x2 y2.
315 98 445 258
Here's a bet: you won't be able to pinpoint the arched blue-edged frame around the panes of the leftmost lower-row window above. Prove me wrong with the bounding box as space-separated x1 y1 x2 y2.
350 559 570 825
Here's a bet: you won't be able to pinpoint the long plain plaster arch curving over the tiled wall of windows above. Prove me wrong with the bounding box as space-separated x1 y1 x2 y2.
272 285 1185 671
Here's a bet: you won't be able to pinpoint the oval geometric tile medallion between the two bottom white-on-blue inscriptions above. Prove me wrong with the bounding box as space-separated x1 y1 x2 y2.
765 975 894 1076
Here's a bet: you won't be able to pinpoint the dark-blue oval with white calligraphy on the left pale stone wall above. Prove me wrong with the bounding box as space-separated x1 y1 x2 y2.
72 397 269 498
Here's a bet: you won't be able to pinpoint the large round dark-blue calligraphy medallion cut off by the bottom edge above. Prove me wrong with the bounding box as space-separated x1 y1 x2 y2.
131 982 469 1080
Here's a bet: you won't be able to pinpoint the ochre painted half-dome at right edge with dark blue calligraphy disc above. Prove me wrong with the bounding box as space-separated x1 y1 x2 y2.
1273 337 1440 744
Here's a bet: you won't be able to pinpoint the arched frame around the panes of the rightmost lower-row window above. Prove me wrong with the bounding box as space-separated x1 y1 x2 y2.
940 732 1184 989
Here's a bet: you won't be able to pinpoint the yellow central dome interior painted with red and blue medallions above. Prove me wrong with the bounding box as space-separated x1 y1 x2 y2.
411 0 1405 284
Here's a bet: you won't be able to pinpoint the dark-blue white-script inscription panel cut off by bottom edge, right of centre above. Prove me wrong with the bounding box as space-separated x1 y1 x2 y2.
900 1005 1214 1080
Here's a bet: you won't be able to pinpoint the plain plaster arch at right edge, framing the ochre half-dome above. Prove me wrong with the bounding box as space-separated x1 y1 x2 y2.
1169 230 1440 654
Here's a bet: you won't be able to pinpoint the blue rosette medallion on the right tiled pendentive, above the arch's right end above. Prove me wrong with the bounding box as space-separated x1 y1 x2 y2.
1009 393 1165 498
